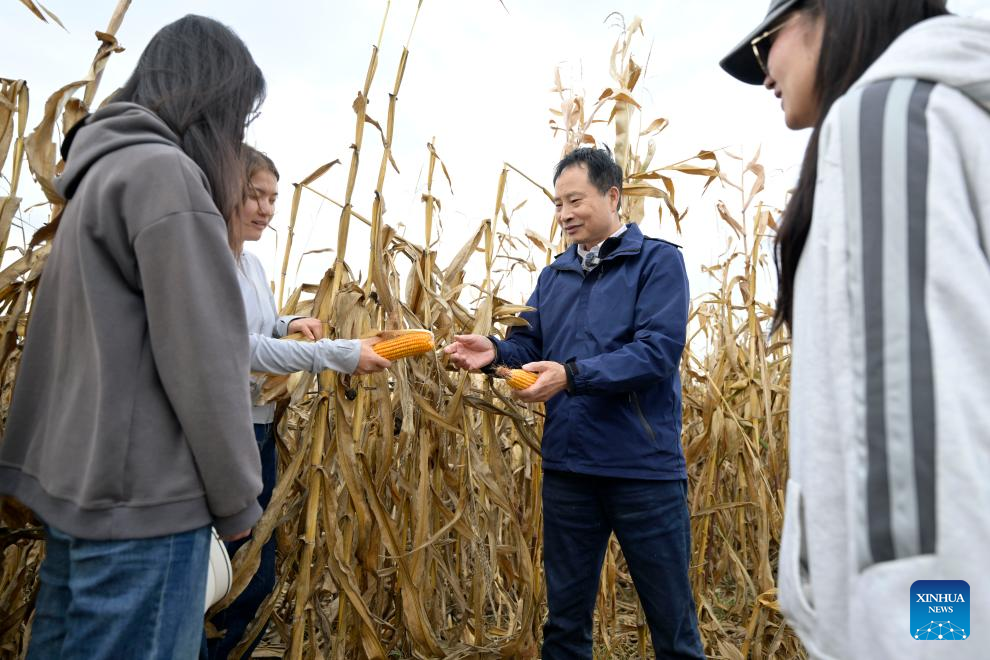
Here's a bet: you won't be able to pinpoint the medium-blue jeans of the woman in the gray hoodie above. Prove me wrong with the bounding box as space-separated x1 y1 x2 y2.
28 526 210 660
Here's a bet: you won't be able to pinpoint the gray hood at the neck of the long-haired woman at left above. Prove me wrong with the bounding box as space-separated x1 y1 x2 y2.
55 103 181 199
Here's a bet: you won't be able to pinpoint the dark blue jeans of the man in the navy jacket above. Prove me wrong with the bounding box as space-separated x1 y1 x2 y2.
542 470 705 660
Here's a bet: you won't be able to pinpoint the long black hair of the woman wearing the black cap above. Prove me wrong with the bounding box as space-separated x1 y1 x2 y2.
773 0 948 330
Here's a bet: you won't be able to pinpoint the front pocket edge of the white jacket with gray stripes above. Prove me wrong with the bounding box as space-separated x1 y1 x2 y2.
778 479 815 638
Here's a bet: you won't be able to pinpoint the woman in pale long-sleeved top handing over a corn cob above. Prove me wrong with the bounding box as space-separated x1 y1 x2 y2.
200 145 391 658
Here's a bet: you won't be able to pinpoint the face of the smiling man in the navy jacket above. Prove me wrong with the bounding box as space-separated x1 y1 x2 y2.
554 163 619 248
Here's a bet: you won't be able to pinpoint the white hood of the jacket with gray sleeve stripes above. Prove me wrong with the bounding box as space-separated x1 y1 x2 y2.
853 16 990 112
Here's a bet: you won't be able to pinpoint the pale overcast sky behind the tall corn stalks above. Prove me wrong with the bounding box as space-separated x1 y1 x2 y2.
0 0 988 302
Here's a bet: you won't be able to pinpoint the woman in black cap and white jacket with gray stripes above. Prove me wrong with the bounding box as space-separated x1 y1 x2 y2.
722 0 990 658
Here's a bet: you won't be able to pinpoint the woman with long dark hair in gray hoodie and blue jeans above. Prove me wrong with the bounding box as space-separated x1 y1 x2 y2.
0 16 265 660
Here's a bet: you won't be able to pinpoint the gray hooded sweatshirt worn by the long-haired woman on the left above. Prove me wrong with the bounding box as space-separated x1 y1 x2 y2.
0 103 261 540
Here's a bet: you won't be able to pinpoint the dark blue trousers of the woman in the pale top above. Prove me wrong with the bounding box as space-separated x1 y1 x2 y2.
200 424 278 660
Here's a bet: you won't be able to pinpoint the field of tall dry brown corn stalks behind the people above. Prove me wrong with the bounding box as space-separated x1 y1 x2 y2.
0 0 804 660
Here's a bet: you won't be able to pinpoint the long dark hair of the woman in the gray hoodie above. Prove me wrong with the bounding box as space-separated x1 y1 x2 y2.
113 14 265 218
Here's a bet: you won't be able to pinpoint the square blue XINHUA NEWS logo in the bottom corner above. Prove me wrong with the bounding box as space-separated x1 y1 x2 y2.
911 580 970 642
